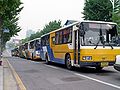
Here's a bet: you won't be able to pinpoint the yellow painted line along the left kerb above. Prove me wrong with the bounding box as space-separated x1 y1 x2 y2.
6 59 27 90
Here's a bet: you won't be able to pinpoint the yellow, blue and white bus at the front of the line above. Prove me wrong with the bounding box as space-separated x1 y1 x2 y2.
40 21 120 70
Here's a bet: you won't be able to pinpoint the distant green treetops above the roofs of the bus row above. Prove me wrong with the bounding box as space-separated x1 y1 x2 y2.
22 20 61 43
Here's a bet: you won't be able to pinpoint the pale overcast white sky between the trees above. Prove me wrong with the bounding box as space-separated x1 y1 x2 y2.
14 0 84 39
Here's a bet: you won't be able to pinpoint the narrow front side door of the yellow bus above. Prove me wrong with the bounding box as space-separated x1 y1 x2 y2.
73 30 80 64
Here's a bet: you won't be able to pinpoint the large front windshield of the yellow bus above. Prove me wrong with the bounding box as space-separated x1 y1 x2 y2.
80 22 117 46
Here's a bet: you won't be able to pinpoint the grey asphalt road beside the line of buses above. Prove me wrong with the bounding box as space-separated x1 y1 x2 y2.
8 57 120 90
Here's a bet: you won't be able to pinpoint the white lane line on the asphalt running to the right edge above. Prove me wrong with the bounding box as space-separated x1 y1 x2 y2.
74 73 120 89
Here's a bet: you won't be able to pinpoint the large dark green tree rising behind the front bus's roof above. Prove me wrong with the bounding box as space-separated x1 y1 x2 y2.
83 0 112 21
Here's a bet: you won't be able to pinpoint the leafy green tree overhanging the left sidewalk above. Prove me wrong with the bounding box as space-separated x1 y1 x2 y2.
0 0 23 45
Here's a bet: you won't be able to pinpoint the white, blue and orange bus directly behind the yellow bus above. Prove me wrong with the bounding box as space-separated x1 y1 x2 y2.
28 38 41 60
